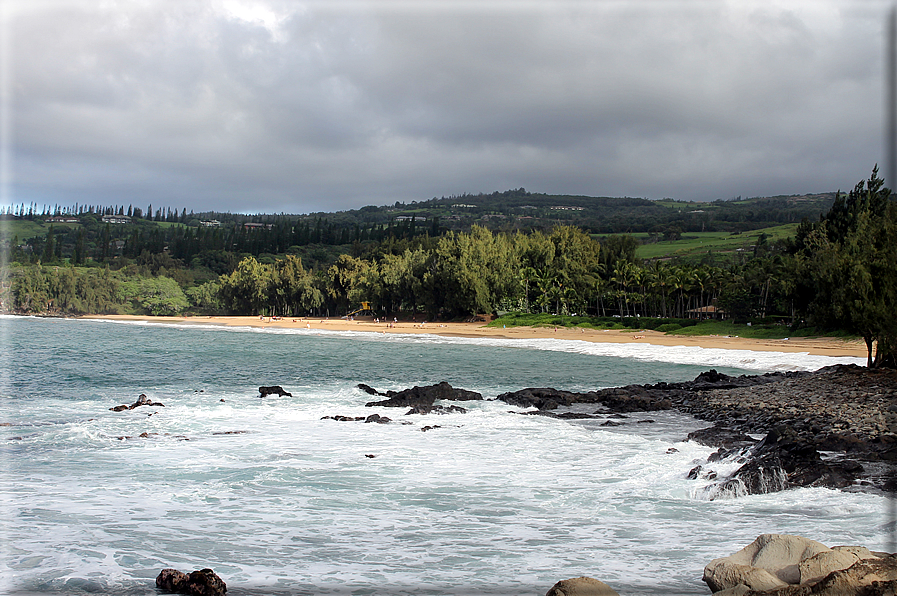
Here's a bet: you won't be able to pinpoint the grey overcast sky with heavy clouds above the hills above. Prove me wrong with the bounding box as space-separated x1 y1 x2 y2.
0 0 891 214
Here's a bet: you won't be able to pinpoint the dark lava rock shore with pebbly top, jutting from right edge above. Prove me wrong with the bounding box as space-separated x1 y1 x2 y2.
498 365 897 498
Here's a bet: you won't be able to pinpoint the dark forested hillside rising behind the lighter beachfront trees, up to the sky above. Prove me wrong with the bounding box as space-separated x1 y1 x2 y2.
0 188 835 273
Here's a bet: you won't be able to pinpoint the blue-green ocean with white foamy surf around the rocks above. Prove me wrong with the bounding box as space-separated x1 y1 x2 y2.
0 317 888 596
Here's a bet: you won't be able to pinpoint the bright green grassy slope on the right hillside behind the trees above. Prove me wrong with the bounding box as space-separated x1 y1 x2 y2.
633 224 798 259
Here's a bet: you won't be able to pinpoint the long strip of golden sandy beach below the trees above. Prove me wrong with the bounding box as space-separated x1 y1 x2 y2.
83 315 866 358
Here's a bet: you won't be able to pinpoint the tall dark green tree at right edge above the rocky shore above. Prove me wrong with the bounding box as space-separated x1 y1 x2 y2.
796 166 897 367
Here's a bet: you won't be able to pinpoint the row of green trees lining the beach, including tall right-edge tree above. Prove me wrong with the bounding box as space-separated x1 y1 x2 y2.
2 168 897 366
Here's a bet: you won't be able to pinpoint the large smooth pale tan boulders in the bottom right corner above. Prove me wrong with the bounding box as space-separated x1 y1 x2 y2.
703 534 897 596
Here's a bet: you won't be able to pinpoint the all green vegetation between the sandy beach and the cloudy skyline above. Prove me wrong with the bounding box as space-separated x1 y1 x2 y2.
0 171 880 354
